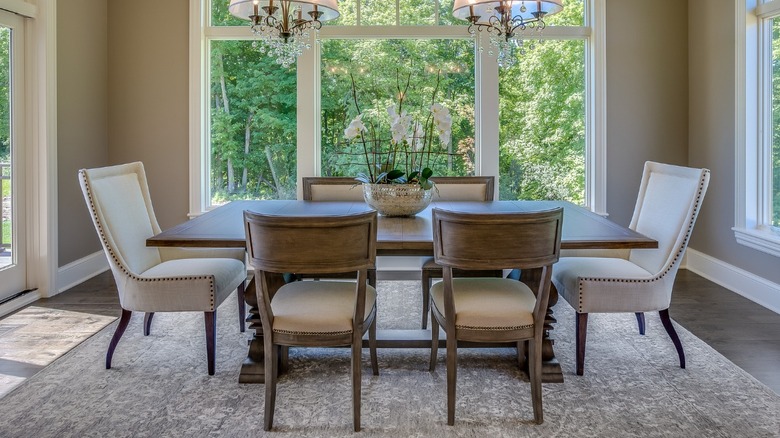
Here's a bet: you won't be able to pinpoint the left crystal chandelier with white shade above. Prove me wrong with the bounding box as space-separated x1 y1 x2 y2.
228 0 339 67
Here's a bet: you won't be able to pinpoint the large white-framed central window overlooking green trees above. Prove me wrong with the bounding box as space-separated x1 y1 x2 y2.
190 0 605 214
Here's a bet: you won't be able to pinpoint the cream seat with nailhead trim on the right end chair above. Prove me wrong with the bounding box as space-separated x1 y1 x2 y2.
553 257 656 313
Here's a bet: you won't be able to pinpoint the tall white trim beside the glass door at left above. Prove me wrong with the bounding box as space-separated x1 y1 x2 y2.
25 0 59 297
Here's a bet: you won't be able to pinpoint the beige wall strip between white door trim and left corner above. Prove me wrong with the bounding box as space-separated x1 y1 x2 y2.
57 0 108 266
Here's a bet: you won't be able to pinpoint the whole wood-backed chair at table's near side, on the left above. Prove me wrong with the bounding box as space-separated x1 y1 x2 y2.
244 211 379 431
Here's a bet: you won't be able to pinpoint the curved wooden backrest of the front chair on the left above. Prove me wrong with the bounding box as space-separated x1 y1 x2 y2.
244 211 377 274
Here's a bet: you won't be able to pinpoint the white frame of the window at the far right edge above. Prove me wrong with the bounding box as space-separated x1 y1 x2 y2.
732 0 780 257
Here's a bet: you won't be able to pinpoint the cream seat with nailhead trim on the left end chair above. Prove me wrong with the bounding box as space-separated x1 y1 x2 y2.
139 258 246 312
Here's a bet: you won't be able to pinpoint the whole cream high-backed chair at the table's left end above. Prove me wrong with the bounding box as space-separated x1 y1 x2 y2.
79 162 246 375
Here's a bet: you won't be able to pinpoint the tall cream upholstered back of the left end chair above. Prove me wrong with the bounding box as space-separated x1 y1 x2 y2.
79 162 161 276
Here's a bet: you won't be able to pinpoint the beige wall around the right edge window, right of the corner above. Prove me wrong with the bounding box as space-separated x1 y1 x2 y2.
688 0 780 283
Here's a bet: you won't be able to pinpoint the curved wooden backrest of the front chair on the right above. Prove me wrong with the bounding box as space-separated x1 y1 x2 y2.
432 207 563 270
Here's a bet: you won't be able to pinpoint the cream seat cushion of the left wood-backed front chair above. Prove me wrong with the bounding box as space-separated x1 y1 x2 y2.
271 281 376 335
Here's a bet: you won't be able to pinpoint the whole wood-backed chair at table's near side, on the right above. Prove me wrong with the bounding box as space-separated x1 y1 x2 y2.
430 208 563 425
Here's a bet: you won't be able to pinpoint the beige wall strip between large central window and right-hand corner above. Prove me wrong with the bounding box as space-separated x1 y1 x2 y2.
607 0 688 225
